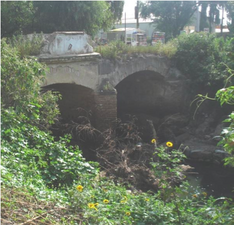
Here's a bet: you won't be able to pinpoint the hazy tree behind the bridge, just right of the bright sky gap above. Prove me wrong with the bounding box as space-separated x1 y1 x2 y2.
140 1 197 40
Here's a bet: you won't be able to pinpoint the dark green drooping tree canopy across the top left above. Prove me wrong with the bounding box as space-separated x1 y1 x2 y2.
1 1 124 37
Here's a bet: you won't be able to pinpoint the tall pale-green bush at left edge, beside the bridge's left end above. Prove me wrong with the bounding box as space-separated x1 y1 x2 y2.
1 40 59 128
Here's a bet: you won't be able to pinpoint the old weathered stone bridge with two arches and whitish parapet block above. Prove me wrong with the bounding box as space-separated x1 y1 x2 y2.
39 32 188 133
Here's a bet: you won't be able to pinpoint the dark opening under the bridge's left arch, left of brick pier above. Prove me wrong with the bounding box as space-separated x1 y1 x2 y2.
42 83 102 161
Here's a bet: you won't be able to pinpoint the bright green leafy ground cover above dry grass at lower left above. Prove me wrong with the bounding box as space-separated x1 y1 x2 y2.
1 109 97 187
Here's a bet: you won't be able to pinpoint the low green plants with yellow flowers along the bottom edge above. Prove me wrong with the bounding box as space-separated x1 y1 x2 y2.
69 177 234 225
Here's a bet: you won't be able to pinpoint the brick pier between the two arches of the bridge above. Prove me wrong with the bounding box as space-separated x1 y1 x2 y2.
94 92 117 131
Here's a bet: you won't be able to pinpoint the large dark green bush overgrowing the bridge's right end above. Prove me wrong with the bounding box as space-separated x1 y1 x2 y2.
173 32 233 87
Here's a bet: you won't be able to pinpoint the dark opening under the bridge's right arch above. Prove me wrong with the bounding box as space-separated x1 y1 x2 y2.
115 70 166 117
